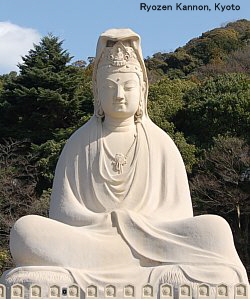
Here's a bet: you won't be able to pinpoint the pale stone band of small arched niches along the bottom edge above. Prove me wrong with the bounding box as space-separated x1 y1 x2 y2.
0 283 249 299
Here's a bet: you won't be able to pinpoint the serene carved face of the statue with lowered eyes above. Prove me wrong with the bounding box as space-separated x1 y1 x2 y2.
97 73 141 119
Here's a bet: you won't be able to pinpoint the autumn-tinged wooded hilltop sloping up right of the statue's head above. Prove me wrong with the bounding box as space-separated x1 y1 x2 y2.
145 20 250 82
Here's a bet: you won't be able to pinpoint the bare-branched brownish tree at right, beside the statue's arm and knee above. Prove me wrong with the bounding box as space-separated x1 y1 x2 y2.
191 135 250 265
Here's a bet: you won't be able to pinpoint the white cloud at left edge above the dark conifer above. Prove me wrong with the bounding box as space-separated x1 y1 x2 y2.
0 22 41 74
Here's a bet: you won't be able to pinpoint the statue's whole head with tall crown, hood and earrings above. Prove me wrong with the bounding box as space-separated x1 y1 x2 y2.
93 29 148 121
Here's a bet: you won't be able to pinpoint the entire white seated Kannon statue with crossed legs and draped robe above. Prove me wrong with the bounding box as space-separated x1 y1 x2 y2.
1 29 247 296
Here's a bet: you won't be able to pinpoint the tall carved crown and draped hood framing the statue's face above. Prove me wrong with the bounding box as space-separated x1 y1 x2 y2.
93 29 148 118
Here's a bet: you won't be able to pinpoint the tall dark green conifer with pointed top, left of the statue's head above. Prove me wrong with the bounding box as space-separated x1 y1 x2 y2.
0 35 91 144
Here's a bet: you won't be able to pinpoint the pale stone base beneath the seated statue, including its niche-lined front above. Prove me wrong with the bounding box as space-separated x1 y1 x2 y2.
0 265 248 299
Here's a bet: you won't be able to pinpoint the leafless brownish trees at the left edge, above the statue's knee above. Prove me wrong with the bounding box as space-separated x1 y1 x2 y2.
0 139 48 272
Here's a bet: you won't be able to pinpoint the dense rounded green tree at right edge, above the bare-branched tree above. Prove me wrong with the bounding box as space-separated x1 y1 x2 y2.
176 74 250 146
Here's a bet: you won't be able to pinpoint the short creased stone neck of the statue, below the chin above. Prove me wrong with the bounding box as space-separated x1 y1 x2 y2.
103 116 135 132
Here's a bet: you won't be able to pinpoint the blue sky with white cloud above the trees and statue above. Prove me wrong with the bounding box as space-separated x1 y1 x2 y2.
0 0 250 74
